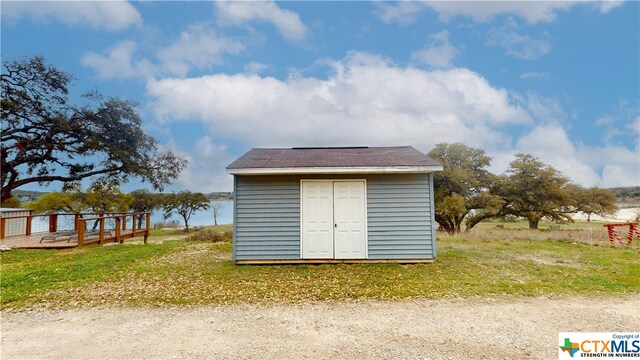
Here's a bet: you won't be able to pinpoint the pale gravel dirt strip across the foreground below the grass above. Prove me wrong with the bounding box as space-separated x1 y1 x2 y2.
0 296 640 359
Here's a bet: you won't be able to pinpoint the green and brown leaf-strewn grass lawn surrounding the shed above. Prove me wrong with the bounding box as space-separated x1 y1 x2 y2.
0 223 640 309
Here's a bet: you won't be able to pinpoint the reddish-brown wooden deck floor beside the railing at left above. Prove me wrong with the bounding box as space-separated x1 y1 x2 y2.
0 229 145 249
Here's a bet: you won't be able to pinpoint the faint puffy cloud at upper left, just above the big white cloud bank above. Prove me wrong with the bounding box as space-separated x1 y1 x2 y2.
157 24 244 76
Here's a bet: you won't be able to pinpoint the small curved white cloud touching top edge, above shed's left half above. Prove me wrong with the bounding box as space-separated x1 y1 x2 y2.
215 1 308 42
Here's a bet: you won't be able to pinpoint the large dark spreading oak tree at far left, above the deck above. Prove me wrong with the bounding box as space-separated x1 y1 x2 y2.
0 57 186 201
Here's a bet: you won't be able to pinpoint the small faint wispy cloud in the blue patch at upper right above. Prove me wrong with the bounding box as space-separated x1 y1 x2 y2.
487 26 551 60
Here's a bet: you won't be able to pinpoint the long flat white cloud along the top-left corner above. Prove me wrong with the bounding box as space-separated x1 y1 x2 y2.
2 1 142 31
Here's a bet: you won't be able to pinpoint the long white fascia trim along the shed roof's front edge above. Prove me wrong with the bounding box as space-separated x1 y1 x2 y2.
227 165 443 175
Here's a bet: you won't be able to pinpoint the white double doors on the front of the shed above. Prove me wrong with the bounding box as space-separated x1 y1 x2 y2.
301 180 367 259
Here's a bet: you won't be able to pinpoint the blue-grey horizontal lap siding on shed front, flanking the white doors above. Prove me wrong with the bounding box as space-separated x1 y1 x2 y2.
234 174 435 260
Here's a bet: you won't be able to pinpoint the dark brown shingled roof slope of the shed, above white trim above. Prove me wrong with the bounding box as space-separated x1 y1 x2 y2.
227 146 441 169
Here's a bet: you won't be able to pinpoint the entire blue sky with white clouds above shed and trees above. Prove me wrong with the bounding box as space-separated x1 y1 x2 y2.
1 1 640 192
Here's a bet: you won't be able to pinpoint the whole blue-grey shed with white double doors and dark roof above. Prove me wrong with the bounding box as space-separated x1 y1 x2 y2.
227 146 442 264
